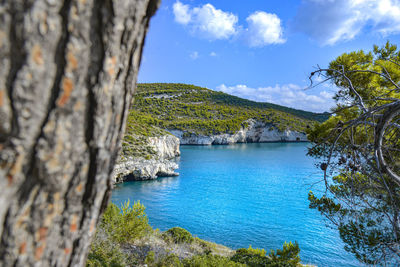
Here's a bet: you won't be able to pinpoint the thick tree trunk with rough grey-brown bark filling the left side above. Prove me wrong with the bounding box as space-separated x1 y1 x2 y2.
0 0 159 266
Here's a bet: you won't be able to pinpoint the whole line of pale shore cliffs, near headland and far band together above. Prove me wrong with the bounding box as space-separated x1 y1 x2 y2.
113 119 307 183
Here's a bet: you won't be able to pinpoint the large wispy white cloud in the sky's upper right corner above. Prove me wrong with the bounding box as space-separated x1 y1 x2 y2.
295 0 400 45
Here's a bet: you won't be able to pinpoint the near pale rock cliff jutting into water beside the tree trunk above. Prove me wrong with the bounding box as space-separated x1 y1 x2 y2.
112 135 180 183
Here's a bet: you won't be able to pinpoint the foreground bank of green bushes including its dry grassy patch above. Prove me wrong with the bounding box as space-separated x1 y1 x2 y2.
86 202 300 267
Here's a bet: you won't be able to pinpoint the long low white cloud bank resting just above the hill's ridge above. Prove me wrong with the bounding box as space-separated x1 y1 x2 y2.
216 84 335 112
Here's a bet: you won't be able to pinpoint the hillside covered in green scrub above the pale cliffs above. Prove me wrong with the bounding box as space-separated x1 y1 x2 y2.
127 83 328 136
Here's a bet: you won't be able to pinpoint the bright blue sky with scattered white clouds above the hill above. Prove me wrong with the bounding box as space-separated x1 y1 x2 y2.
138 0 400 112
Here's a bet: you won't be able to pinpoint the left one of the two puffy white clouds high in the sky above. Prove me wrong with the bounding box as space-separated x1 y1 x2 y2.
173 1 238 40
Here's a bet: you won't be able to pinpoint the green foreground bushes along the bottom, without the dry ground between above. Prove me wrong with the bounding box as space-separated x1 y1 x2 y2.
86 202 300 267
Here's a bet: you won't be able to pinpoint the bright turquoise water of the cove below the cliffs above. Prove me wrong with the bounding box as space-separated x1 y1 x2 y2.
112 143 361 266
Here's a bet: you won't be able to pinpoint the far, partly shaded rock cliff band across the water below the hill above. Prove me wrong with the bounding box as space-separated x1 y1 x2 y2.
169 119 308 145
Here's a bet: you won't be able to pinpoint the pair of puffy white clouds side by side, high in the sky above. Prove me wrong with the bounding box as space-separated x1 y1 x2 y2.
173 0 285 47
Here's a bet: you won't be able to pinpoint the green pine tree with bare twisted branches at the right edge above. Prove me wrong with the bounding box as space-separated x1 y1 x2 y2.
309 42 400 266
